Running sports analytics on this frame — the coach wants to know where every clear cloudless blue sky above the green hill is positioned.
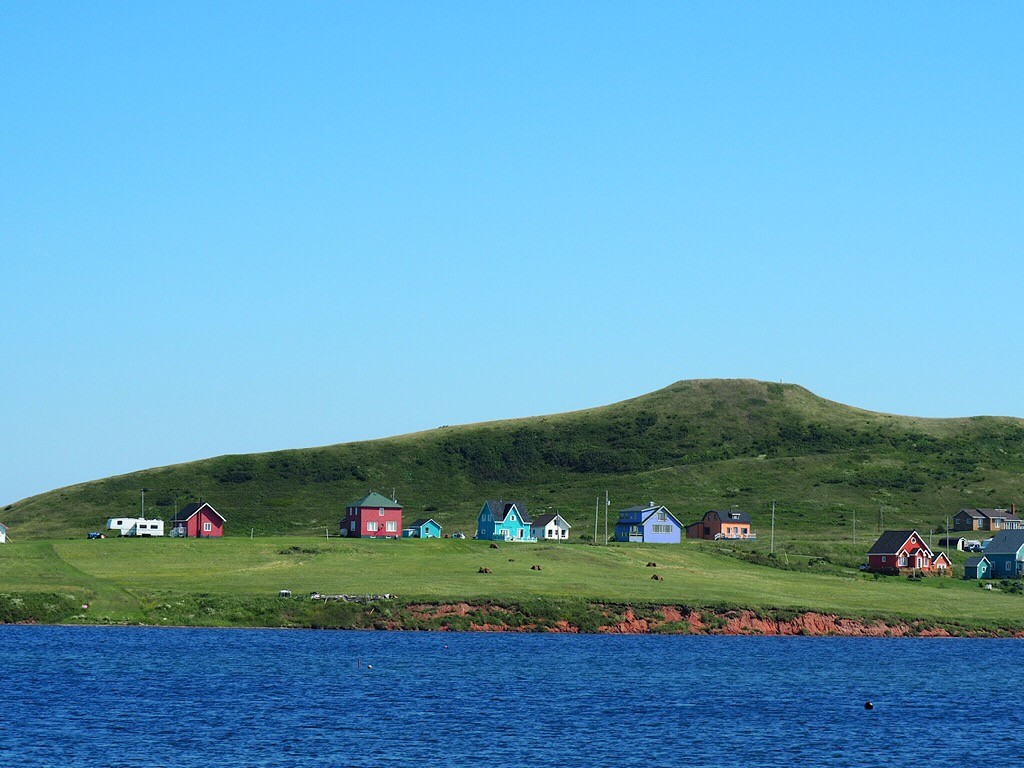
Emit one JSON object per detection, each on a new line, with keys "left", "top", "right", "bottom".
{"left": 0, "top": 2, "right": 1024, "bottom": 502}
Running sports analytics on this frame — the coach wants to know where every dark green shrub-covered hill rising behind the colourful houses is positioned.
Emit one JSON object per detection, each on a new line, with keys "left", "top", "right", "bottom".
{"left": 6, "top": 380, "right": 1024, "bottom": 542}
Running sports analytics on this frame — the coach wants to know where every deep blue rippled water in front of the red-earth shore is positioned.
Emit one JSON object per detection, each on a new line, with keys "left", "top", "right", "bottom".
{"left": 0, "top": 626, "right": 1024, "bottom": 768}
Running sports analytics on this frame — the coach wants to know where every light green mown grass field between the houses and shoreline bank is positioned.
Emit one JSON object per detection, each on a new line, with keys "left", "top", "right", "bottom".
{"left": 0, "top": 537, "right": 1024, "bottom": 629}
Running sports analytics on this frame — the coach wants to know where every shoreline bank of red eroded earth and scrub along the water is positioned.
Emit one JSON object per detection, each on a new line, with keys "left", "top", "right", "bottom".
{"left": 8, "top": 595, "right": 1024, "bottom": 639}
